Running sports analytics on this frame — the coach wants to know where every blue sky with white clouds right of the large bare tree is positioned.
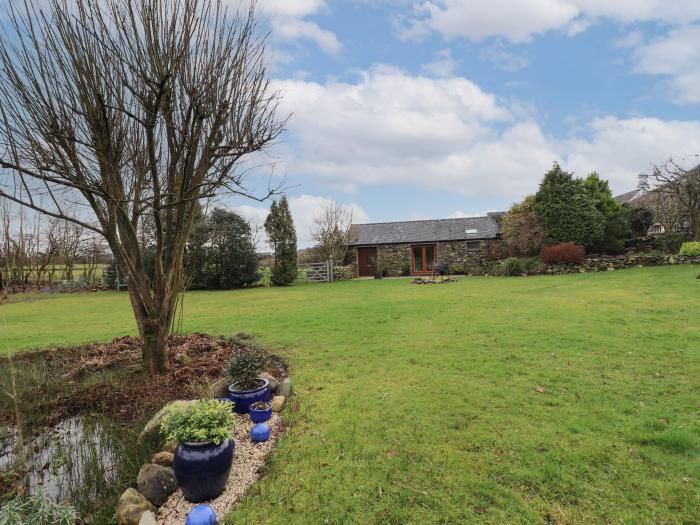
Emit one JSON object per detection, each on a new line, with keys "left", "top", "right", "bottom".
{"left": 221, "top": 0, "right": 700, "bottom": 245}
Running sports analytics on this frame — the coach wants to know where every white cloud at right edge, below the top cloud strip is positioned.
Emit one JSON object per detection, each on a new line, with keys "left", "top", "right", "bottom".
{"left": 633, "top": 24, "right": 700, "bottom": 104}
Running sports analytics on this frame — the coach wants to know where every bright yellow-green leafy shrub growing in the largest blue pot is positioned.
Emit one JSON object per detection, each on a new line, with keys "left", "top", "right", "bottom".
{"left": 160, "top": 399, "right": 233, "bottom": 445}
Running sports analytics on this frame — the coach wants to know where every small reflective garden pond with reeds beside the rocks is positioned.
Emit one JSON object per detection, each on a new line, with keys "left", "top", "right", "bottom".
{"left": 0, "top": 417, "right": 149, "bottom": 524}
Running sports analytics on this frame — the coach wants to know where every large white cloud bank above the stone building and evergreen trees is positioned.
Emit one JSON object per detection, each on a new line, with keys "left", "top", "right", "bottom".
{"left": 276, "top": 66, "right": 700, "bottom": 202}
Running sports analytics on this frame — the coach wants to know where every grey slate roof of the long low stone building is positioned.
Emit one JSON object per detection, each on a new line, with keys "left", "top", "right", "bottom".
{"left": 348, "top": 214, "right": 500, "bottom": 246}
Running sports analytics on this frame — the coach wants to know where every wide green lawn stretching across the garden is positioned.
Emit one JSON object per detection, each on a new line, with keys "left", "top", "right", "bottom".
{"left": 0, "top": 267, "right": 700, "bottom": 525}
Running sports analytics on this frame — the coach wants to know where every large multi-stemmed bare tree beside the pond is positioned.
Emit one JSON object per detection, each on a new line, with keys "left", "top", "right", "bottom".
{"left": 0, "top": 0, "right": 285, "bottom": 373}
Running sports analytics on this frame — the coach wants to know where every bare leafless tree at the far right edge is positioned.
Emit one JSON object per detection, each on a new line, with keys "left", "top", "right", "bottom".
{"left": 639, "top": 159, "right": 700, "bottom": 241}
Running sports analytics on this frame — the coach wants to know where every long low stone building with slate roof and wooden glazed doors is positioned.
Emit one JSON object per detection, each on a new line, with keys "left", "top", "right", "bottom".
{"left": 345, "top": 213, "right": 502, "bottom": 277}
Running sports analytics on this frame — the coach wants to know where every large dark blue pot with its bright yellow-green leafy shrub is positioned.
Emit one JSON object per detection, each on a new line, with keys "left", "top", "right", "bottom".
{"left": 161, "top": 399, "right": 235, "bottom": 503}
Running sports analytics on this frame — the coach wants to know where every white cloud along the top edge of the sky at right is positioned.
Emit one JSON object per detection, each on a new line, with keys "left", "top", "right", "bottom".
{"left": 400, "top": 0, "right": 700, "bottom": 42}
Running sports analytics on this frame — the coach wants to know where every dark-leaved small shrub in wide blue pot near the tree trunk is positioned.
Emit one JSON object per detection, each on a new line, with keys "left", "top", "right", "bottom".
{"left": 227, "top": 346, "right": 270, "bottom": 414}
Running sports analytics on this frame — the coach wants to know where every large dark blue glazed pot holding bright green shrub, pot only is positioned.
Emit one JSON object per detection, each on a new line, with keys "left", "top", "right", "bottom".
{"left": 173, "top": 439, "right": 236, "bottom": 503}
